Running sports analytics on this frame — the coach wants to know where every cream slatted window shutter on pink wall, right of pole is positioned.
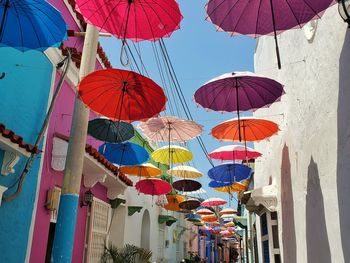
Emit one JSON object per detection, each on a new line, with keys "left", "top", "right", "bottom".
{"left": 85, "top": 197, "right": 111, "bottom": 263}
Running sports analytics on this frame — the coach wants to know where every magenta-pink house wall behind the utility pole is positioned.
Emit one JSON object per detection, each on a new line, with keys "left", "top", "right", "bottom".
{"left": 30, "top": 0, "right": 112, "bottom": 263}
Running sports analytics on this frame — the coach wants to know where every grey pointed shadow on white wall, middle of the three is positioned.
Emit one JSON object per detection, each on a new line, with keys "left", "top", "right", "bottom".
{"left": 306, "top": 157, "right": 332, "bottom": 263}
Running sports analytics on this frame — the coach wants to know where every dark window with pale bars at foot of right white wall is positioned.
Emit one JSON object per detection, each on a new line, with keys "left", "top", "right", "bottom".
{"left": 260, "top": 211, "right": 281, "bottom": 263}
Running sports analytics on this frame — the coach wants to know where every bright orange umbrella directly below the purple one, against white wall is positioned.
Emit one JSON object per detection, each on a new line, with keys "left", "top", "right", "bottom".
{"left": 211, "top": 117, "right": 278, "bottom": 142}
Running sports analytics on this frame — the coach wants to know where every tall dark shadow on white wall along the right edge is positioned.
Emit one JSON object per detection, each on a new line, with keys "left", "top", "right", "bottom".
{"left": 337, "top": 29, "right": 350, "bottom": 262}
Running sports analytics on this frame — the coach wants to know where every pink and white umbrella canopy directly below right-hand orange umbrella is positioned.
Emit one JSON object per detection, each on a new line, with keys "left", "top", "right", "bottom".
{"left": 208, "top": 145, "right": 261, "bottom": 161}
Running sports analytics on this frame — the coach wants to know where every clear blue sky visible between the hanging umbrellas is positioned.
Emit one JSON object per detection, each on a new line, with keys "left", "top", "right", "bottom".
{"left": 100, "top": 0, "right": 255, "bottom": 206}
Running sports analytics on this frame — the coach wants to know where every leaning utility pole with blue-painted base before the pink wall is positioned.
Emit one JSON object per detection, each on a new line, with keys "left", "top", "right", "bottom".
{"left": 51, "top": 24, "right": 98, "bottom": 263}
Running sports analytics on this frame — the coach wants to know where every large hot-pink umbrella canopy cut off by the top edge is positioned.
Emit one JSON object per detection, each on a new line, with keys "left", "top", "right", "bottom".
{"left": 75, "top": 0, "right": 182, "bottom": 41}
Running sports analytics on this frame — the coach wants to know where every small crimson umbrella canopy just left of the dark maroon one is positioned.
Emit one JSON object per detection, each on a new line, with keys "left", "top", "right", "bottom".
{"left": 135, "top": 178, "right": 172, "bottom": 196}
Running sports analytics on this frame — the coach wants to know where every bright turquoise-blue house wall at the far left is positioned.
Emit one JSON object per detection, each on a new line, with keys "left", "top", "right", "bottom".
{"left": 0, "top": 48, "right": 53, "bottom": 262}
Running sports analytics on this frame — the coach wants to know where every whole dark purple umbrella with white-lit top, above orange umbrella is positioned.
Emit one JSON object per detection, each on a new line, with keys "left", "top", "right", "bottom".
{"left": 194, "top": 72, "right": 284, "bottom": 138}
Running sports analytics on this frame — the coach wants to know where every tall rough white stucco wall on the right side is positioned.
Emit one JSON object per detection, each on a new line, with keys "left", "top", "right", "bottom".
{"left": 254, "top": 6, "right": 350, "bottom": 263}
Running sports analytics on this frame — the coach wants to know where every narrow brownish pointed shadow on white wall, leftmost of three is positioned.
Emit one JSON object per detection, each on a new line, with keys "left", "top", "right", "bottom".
{"left": 281, "top": 145, "right": 297, "bottom": 263}
